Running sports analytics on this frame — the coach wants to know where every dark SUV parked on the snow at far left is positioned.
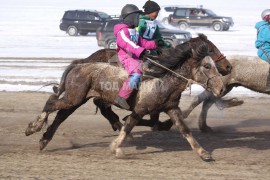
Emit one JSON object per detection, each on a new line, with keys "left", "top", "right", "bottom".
{"left": 60, "top": 10, "right": 112, "bottom": 36}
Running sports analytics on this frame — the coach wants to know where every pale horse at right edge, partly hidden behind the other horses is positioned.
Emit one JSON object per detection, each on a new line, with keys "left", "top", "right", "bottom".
{"left": 180, "top": 56, "right": 270, "bottom": 132}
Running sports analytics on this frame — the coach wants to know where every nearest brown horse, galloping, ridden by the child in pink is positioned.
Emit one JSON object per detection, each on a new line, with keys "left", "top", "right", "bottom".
{"left": 25, "top": 43, "right": 223, "bottom": 161}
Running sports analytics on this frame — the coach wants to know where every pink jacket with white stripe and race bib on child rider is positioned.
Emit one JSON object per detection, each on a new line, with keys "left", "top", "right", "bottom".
{"left": 114, "top": 24, "right": 157, "bottom": 62}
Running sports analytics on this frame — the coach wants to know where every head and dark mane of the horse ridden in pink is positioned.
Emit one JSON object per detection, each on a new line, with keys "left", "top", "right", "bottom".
{"left": 146, "top": 41, "right": 224, "bottom": 96}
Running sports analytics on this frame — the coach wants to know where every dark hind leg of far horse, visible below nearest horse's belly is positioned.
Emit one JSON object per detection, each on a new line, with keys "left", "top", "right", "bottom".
{"left": 93, "top": 98, "right": 123, "bottom": 131}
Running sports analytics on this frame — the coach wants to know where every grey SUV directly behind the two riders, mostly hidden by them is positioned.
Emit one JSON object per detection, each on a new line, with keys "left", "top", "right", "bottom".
{"left": 96, "top": 19, "right": 191, "bottom": 49}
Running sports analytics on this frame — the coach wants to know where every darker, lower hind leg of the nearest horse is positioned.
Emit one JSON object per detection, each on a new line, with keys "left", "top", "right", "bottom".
{"left": 39, "top": 100, "right": 87, "bottom": 150}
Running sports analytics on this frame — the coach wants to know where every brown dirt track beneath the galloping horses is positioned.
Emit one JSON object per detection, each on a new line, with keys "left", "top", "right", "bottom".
{"left": 0, "top": 92, "right": 270, "bottom": 180}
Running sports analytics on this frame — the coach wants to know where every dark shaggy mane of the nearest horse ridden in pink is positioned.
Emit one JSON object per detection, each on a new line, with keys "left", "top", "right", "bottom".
{"left": 144, "top": 41, "right": 209, "bottom": 77}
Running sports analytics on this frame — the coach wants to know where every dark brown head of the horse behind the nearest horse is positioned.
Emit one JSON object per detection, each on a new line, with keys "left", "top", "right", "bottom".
{"left": 189, "top": 34, "right": 232, "bottom": 76}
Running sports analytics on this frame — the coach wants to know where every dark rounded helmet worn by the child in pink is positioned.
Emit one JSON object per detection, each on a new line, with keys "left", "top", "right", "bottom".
{"left": 121, "top": 4, "right": 142, "bottom": 26}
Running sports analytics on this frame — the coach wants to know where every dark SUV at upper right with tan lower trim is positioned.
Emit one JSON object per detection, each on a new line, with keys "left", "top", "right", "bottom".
{"left": 169, "top": 7, "right": 234, "bottom": 31}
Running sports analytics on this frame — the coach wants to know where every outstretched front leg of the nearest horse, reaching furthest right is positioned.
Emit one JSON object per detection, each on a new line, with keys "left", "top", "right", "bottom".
{"left": 166, "top": 107, "right": 213, "bottom": 161}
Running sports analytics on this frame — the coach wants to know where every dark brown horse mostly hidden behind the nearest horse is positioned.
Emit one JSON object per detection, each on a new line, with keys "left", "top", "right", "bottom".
{"left": 54, "top": 34, "right": 231, "bottom": 131}
